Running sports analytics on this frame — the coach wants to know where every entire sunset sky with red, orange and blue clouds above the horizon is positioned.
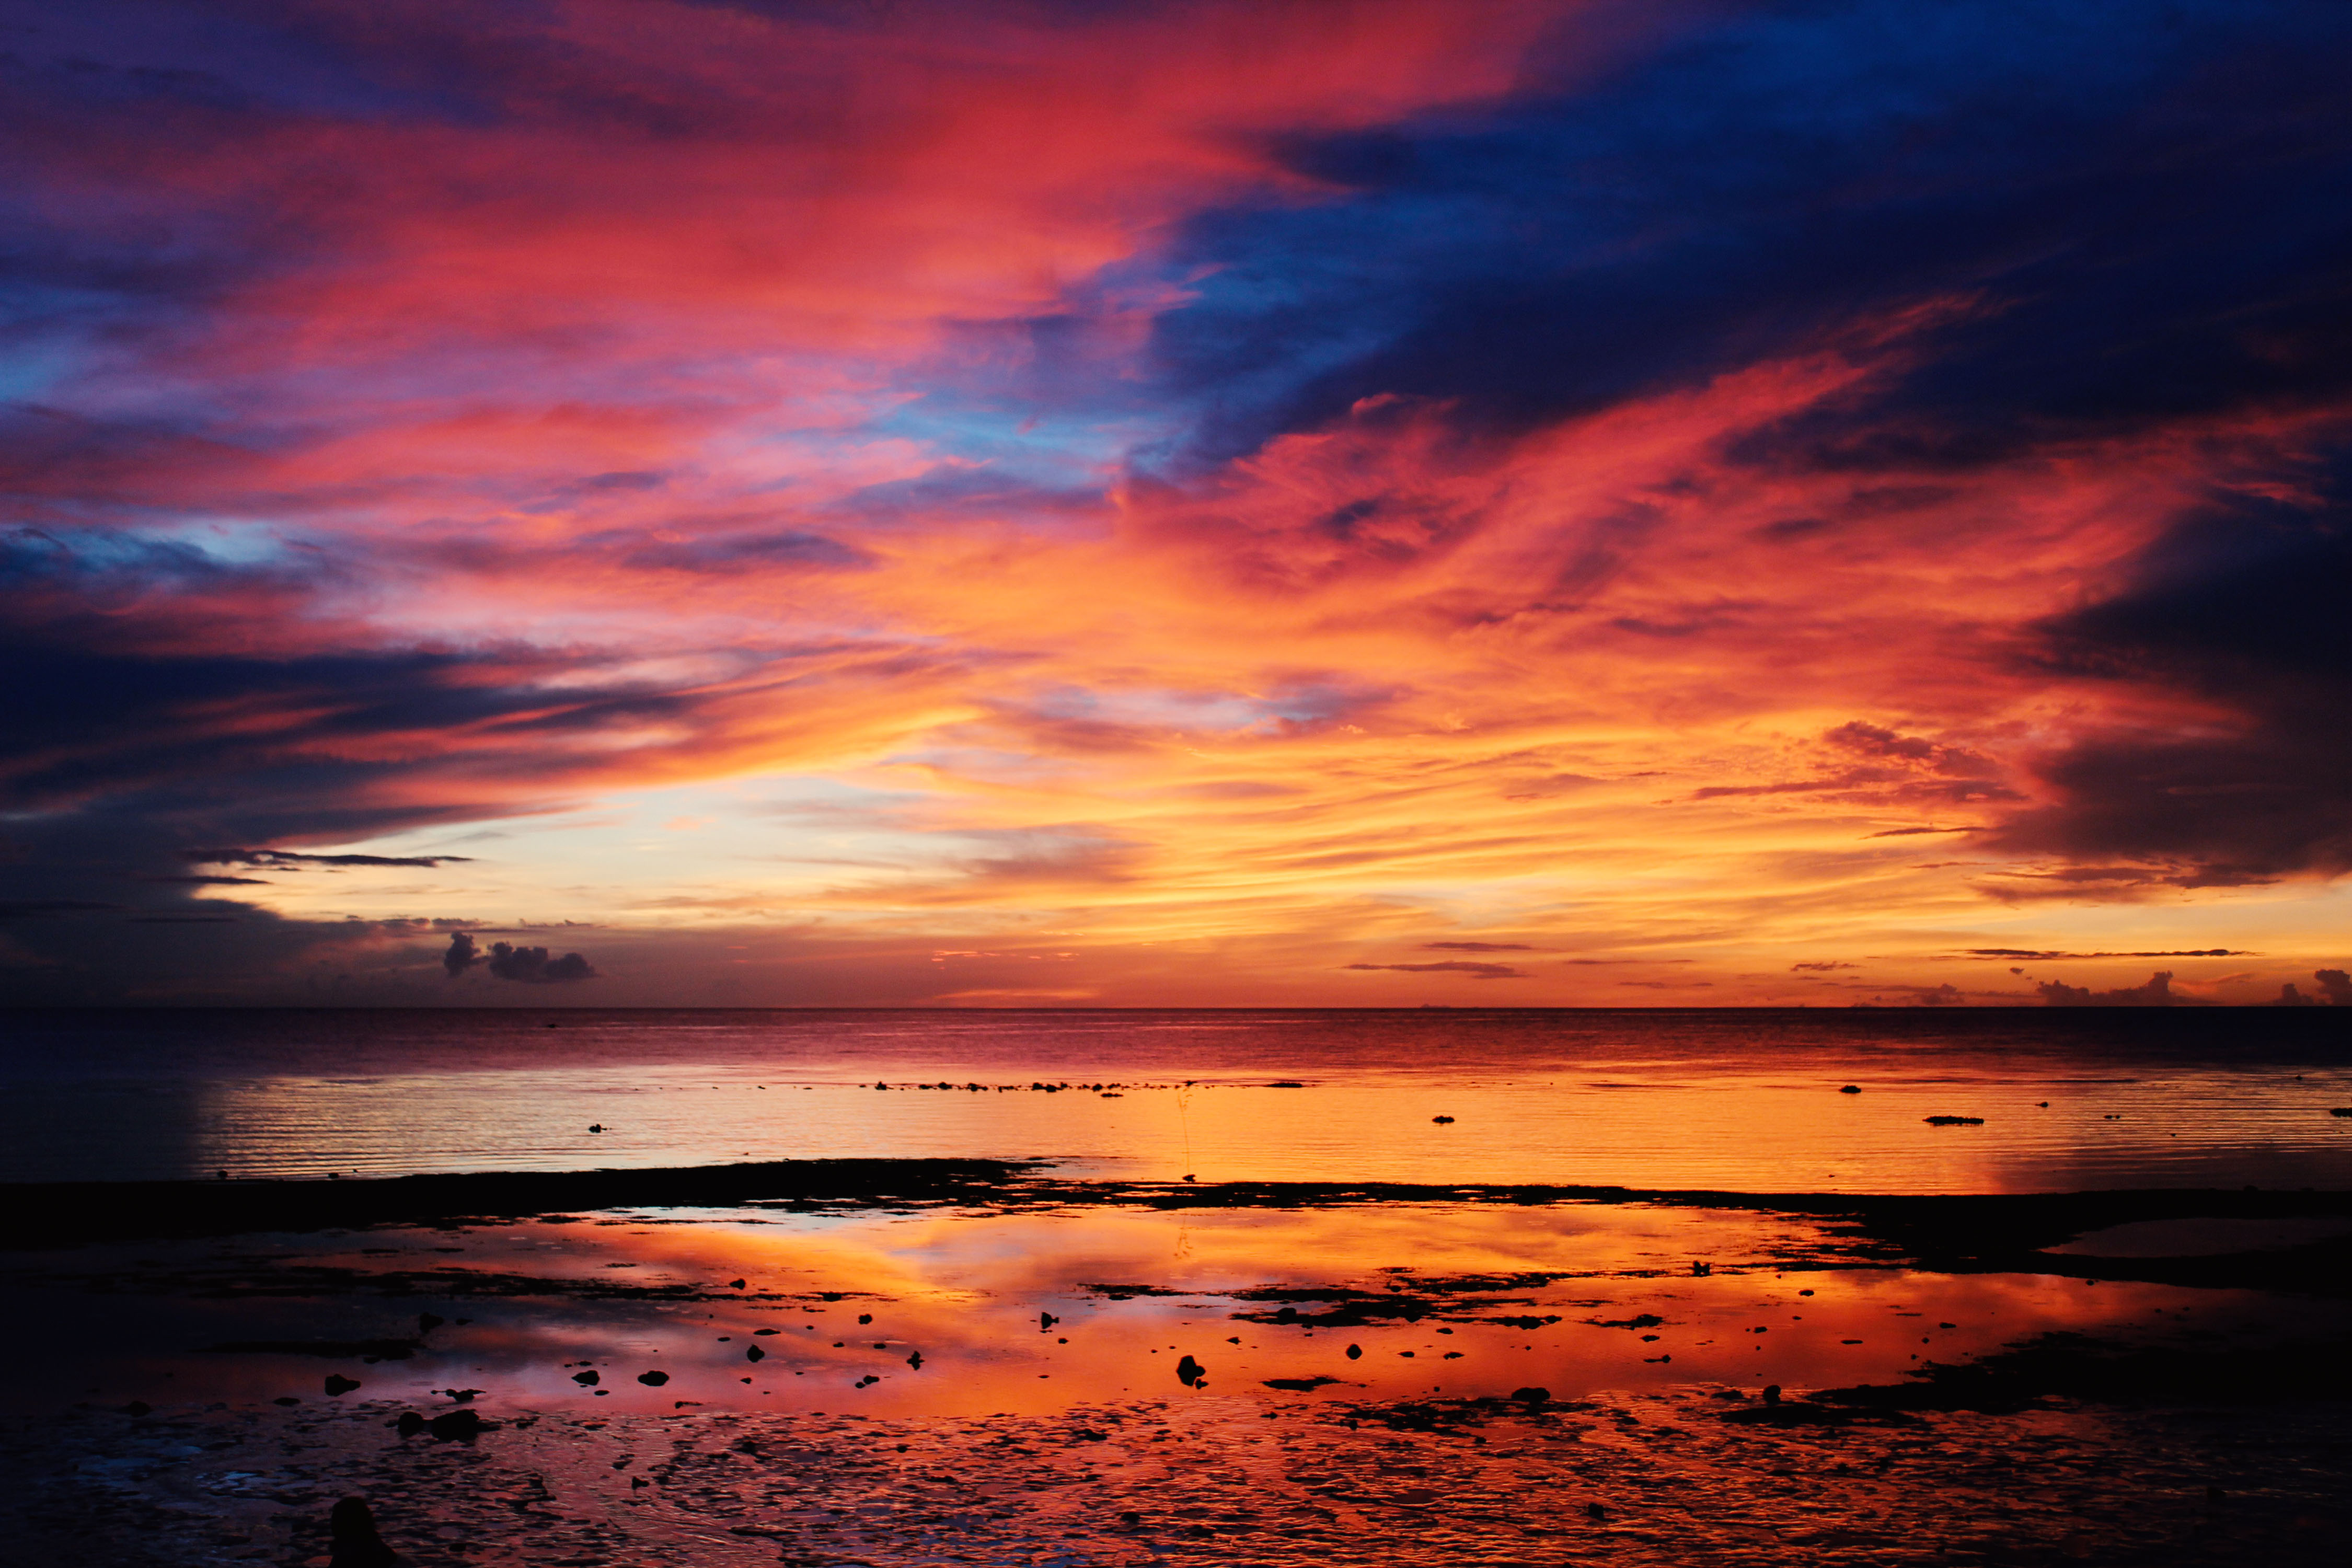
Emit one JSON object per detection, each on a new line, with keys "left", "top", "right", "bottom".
{"left": 0, "top": 0, "right": 2352, "bottom": 1006}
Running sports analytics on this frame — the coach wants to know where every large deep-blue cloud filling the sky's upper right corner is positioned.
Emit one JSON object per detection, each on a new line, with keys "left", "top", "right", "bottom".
{"left": 1138, "top": 0, "right": 2352, "bottom": 466}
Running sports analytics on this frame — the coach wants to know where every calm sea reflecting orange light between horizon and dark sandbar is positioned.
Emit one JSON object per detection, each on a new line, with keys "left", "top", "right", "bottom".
{"left": 0, "top": 1009, "right": 2352, "bottom": 1192}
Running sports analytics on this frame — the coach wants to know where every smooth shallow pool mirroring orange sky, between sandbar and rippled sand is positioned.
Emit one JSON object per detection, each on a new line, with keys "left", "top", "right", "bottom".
{"left": 12, "top": 1204, "right": 2331, "bottom": 1417}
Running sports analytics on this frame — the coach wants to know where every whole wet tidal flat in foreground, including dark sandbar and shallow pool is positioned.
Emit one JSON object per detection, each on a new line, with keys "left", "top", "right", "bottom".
{"left": 0, "top": 1161, "right": 2352, "bottom": 1568}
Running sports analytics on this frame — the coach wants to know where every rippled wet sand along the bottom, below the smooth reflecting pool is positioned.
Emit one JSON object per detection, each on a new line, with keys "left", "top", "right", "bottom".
{"left": 0, "top": 1389, "right": 2352, "bottom": 1568}
